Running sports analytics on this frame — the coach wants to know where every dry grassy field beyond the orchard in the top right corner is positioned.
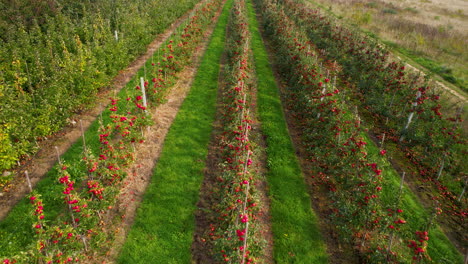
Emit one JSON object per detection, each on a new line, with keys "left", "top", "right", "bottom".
{"left": 308, "top": 0, "right": 468, "bottom": 96}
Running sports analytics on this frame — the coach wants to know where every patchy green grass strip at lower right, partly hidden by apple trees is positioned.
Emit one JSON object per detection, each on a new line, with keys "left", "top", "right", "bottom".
{"left": 361, "top": 133, "right": 463, "bottom": 264}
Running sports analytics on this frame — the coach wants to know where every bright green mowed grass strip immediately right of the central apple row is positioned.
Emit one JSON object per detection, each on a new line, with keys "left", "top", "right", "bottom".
{"left": 247, "top": 0, "right": 328, "bottom": 263}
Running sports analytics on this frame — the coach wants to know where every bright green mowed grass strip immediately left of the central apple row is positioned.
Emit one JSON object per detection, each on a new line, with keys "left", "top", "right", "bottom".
{"left": 118, "top": 0, "right": 233, "bottom": 263}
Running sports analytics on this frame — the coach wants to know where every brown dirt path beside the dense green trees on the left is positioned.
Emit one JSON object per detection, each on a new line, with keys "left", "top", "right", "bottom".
{"left": 0, "top": 3, "right": 200, "bottom": 221}
